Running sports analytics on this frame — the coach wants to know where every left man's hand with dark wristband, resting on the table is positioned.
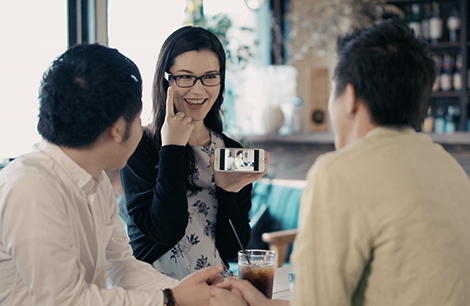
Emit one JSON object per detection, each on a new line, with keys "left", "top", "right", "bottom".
{"left": 172, "top": 265, "right": 223, "bottom": 306}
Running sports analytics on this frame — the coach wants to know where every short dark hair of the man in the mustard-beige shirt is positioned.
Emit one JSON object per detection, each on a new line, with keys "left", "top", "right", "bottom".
{"left": 334, "top": 19, "right": 435, "bottom": 129}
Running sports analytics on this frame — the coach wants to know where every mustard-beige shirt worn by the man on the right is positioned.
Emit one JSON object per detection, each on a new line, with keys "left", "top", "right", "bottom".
{"left": 291, "top": 127, "right": 470, "bottom": 306}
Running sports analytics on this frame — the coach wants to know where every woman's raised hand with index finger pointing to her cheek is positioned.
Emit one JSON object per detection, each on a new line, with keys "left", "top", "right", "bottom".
{"left": 161, "top": 86, "right": 194, "bottom": 146}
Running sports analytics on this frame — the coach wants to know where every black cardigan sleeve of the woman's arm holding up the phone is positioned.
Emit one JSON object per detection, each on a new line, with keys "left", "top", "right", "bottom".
{"left": 215, "top": 135, "right": 252, "bottom": 260}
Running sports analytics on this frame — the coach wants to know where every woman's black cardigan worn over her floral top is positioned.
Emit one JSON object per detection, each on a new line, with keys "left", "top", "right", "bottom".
{"left": 121, "top": 131, "right": 252, "bottom": 264}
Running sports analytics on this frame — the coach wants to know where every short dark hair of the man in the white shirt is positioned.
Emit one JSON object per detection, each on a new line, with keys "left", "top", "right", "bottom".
{"left": 38, "top": 44, "right": 142, "bottom": 148}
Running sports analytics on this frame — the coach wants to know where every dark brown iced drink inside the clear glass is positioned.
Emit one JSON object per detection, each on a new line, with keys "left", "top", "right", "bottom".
{"left": 238, "top": 262, "right": 274, "bottom": 299}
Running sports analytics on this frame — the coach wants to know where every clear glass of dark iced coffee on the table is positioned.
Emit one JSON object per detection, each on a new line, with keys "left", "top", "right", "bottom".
{"left": 238, "top": 250, "right": 276, "bottom": 299}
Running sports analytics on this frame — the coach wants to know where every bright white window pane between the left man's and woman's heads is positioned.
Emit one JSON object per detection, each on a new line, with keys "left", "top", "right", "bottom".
{"left": 108, "top": 0, "right": 186, "bottom": 125}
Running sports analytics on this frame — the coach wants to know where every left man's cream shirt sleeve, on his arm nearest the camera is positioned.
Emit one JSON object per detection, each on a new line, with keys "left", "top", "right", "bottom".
{"left": 0, "top": 176, "right": 163, "bottom": 306}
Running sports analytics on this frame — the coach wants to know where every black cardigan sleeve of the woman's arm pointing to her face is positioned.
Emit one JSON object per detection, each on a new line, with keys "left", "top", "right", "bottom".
{"left": 121, "top": 133, "right": 188, "bottom": 262}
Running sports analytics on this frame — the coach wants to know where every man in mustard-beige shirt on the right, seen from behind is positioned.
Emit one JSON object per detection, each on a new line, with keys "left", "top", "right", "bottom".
{"left": 211, "top": 20, "right": 470, "bottom": 306}
